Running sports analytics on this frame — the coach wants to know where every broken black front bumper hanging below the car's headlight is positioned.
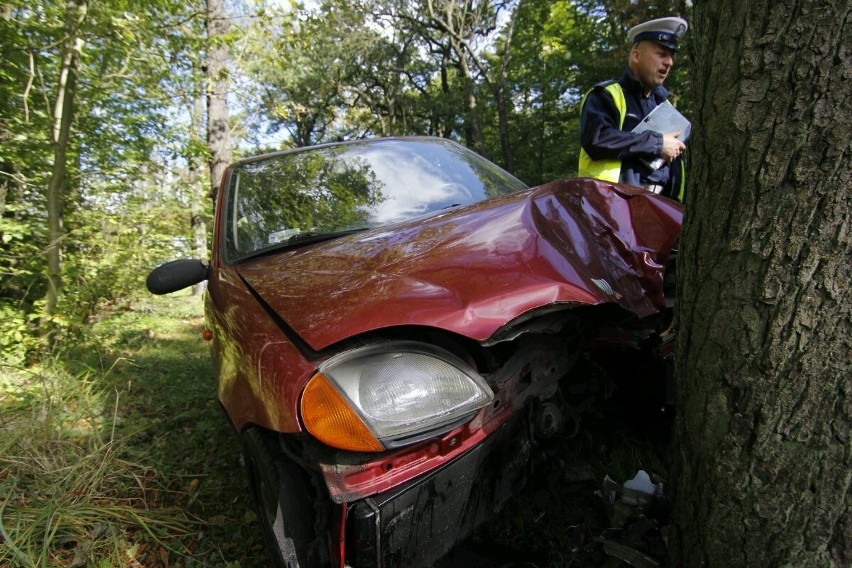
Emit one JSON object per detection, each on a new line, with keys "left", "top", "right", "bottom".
{"left": 345, "top": 415, "right": 532, "bottom": 568}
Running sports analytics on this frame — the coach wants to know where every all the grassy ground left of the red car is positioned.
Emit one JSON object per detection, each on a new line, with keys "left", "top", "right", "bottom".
{"left": 0, "top": 295, "right": 264, "bottom": 568}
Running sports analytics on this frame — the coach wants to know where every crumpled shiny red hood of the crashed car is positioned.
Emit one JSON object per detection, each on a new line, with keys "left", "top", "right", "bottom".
{"left": 238, "top": 179, "right": 682, "bottom": 350}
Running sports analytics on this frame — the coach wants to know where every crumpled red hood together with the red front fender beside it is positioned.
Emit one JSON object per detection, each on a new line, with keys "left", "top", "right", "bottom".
{"left": 207, "top": 179, "right": 682, "bottom": 432}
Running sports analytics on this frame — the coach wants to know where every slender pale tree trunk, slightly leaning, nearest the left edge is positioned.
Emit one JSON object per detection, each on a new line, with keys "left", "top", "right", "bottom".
{"left": 45, "top": 0, "right": 87, "bottom": 320}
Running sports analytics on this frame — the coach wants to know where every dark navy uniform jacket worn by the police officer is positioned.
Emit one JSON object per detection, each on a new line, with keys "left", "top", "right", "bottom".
{"left": 580, "top": 68, "right": 683, "bottom": 199}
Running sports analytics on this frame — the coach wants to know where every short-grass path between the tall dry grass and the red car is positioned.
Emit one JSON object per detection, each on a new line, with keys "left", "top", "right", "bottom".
{"left": 69, "top": 297, "right": 267, "bottom": 568}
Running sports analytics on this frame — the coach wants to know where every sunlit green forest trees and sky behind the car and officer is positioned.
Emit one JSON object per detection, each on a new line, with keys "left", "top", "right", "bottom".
{"left": 0, "top": 0, "right": 689, "bottom": 356}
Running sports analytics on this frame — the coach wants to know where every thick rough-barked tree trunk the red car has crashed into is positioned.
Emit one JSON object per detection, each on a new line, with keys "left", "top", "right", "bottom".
{"left": 670, "top": 0, "right": 852, "bottom": 568}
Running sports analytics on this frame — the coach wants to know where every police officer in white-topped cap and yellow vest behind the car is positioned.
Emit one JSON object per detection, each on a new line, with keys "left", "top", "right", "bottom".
{"left": 579, "top": 17, "right": 687, "bottom": 201}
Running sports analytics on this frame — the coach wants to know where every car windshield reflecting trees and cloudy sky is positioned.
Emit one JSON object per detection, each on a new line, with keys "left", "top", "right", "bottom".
{"left": 224, "top": 138, "right": 526, "bottom": 262}
